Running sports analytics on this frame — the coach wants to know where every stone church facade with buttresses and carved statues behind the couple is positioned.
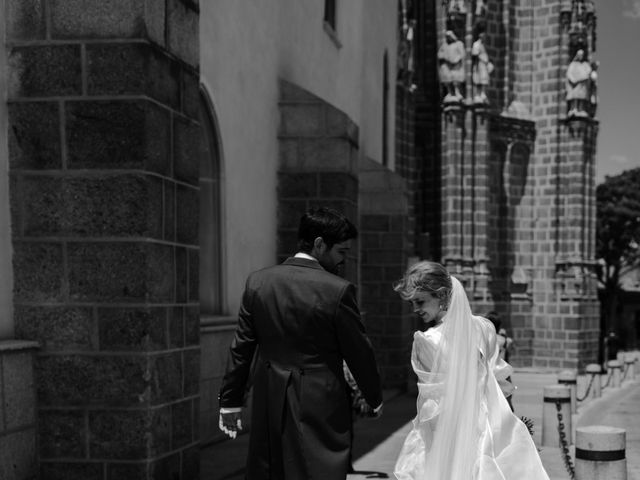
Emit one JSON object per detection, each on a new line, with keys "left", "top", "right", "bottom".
{"left": 0, "top": 0, "right": 599, "bottom": 480}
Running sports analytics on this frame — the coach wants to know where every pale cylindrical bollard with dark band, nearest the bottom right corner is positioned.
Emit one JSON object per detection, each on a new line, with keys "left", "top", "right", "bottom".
{"left": 575, "top": 425, "right": 627, "bottom": 480}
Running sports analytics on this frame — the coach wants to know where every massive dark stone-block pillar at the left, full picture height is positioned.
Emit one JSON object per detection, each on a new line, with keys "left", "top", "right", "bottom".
{"left": 7, "top": 0, "right": 200, "bottom": 480}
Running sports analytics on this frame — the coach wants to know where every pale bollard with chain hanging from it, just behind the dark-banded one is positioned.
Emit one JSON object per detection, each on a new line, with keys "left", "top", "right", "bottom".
{"left": 542, "top": 385, "right": 571, "bottom": 447}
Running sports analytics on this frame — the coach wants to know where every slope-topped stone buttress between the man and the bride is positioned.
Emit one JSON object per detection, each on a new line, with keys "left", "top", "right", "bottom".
{"left": 358, "top": 159, "right": 410, "bottom": 389}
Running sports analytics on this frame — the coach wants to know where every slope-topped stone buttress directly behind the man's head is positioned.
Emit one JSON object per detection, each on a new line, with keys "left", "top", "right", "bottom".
{"left": 278, "top": 80, "right": 358, "bottom": 283}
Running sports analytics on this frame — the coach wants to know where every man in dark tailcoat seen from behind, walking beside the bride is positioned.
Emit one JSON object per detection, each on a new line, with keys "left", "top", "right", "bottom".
{"left": 219, "top": 208, "right": 382, "bottom": 480}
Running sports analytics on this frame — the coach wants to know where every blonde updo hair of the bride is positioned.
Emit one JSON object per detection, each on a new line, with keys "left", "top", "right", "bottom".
{"left": 393, "top": 260, "right": 452, "bottom": 309}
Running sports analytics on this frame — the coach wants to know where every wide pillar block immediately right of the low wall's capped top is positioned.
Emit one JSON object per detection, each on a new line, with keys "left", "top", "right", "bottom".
{"left": 36, "top": 355, "right": 151, "bottom": 407}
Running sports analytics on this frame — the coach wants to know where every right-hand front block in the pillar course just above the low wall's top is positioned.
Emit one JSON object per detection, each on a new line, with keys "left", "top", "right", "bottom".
{"left": 97, "top": 308, "right": 168, "bottom": 352}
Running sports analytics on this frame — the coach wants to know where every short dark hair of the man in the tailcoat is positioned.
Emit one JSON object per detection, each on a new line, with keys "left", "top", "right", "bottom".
{"left": 298, "top": 207, "right": 358, "bottom": 253}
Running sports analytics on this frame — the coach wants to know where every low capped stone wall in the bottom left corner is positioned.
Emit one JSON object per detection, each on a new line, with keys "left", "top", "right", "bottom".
{"left": 0, "top": 340, "right": 38, "bottom": 480}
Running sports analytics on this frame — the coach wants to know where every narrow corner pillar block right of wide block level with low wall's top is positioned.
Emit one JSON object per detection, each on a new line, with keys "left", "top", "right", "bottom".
{"left": 149, "top": 352, "right": 181, "bottom": 403}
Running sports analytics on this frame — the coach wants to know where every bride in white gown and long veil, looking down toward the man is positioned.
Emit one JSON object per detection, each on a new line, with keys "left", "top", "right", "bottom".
{"left": 394, "top": 261, "right": 549, "bottom": 480}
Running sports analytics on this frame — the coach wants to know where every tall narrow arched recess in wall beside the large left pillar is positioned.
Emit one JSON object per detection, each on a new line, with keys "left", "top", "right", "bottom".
{"left": 199, "top": 86, "right": 225, "bottom": 318}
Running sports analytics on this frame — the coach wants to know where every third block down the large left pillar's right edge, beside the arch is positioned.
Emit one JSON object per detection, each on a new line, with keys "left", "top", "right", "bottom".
{"left": 173, "top": 117, "right": 203, "bottom": 186}
